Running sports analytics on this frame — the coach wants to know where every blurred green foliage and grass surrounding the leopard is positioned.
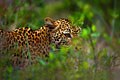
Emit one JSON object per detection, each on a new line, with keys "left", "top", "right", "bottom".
{"left": 0, "top": 0, "right": 120, "bottom": 80}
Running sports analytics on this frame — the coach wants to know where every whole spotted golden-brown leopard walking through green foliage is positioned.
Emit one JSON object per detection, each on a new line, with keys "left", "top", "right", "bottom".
{"left": 0, "top": 17, "right": 81, "bottom": 69}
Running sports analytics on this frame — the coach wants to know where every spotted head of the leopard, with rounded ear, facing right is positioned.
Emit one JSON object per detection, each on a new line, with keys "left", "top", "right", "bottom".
{"left": 45, "top": 17, "right": 81, "bottom": 46}
